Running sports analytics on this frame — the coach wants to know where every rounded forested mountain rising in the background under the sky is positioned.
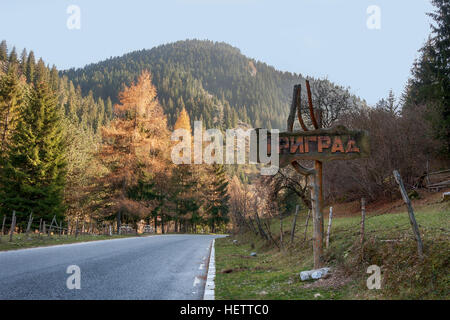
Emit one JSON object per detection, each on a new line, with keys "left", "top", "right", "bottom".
{"left": 62, "top": 40, "right": 362, "bottom": 129}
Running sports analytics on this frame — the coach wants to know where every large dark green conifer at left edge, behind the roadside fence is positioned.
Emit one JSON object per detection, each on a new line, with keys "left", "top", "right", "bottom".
{"left": 0, "top": 82, "right": 66, "bottom": 220}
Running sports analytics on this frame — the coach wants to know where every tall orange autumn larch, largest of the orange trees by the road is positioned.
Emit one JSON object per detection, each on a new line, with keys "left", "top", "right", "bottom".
{"left": 98, "top": 72, "right": 169, "bottom": 228}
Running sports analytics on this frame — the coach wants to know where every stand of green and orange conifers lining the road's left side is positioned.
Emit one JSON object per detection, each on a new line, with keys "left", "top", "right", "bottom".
{"left": 0, "top": 41, "right": 232, "bottom": 233}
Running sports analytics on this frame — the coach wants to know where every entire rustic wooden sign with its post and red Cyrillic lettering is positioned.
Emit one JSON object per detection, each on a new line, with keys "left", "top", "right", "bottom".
{"left": 258, "top": 80, "right": 370, "bottom": 269}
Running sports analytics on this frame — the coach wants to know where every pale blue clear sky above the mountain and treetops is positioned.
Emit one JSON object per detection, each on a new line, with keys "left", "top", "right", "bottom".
{"left": 0, "top": 0, "right": 433, "bottom": 104}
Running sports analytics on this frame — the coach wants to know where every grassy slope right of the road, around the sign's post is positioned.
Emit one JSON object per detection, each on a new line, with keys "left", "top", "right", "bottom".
{"left": 216, "top": 203, "right": 450, "bottom": 300}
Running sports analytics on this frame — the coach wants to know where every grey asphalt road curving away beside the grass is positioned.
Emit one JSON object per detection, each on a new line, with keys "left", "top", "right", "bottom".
{"left": 0, "top": 235, "right": 222, "bottom": 300}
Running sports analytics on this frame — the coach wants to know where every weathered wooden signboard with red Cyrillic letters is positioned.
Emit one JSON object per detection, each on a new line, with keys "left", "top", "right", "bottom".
{"left": 258, "top": 126, "right": 370, "bottom": 167}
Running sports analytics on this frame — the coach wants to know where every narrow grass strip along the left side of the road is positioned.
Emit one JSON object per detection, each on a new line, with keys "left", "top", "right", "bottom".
{"left": 0, "top": 234, "right": 149, "bottom": 251}
